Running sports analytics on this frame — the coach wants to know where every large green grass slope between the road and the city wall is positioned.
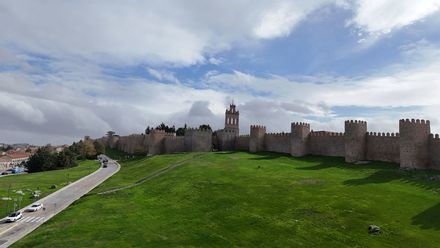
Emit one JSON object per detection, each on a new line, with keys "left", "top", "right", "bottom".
{"left": 15, "top": 152, "right": 440, "bottom": 247}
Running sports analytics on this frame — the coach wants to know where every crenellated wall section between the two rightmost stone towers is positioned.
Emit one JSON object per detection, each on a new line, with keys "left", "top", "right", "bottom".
{"left": 366, "top": 132, "right": 400, "bottom": 163}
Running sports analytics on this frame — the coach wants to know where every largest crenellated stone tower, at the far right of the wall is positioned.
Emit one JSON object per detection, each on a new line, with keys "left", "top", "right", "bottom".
{"left": 399, "top": 119, "right": 431, "bottom": 169}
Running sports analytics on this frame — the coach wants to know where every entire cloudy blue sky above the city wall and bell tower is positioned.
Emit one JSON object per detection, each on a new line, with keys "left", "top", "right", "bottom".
{"left": 0, "top": 0, "right": 440, "bottom": 144}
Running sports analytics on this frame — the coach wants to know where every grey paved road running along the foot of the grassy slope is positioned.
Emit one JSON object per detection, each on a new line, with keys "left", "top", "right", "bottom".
{"left": 0, "top": 158, "right": 120, "bottom": 248}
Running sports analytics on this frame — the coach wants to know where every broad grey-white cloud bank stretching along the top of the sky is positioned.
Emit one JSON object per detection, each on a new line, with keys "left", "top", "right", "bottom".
{"left": 0, "top": 0, "right": 439, "bottom": 66}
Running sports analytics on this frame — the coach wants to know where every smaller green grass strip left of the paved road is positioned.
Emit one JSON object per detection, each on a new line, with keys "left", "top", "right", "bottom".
{"left": 0, "top": 161, "right": 99, "bottom": 219}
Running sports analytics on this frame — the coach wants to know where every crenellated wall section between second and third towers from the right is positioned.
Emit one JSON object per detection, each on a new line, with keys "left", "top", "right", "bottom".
{"left": 309, "top": 132, "right": 345, "bottom": 157}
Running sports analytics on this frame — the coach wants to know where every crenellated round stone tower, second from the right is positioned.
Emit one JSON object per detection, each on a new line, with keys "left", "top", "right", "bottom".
{"left": 345, "top": 120, "right": 367, "bottom": 163}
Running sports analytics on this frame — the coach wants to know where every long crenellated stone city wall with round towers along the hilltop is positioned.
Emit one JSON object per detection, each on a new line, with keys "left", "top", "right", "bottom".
{"left": 97, "top": 116, "right": 440, "bottom": 169}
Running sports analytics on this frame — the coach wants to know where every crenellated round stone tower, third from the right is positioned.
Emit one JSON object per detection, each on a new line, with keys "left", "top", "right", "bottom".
{"left": 290, "top": 122, "right": 310, "bottom": 157}
